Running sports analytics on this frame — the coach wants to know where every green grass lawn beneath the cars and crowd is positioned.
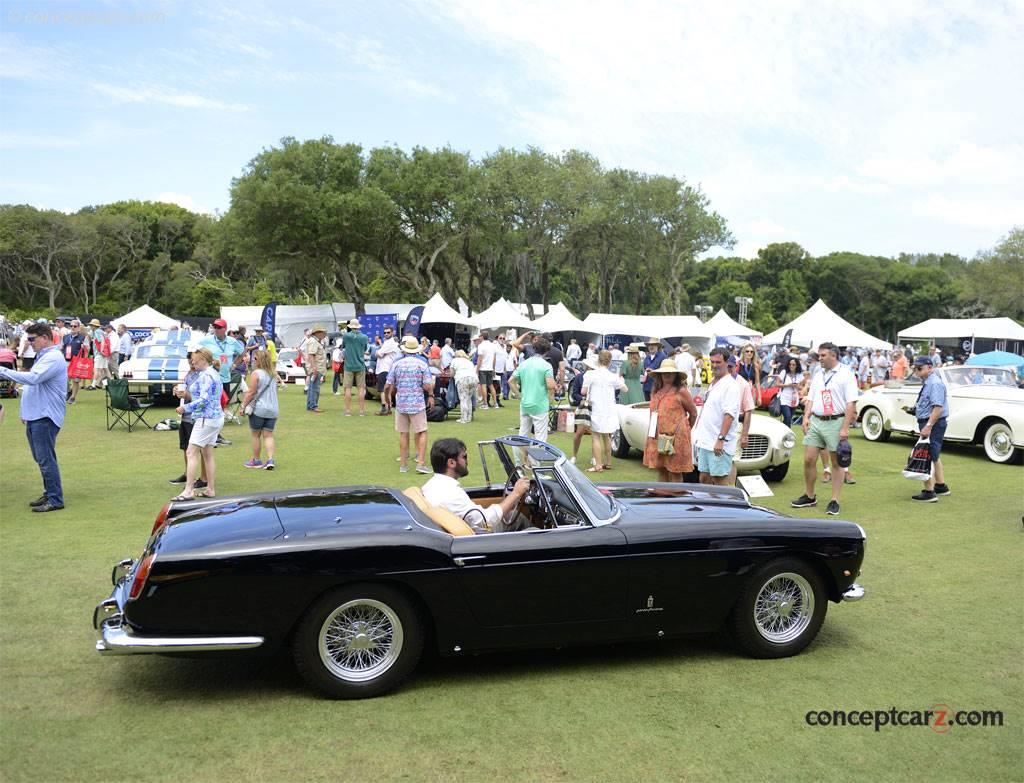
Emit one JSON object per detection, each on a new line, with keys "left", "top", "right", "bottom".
{"left": 0, "top": 387, "right": 1024, "bottom": 781}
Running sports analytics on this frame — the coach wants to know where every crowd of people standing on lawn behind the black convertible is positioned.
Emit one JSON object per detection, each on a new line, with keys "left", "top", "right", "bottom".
{"left": 0, "top": 311, "right": 962, "bottom": 524}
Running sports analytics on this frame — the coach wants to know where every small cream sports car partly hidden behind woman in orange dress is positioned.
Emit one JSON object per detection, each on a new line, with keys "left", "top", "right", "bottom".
{"left": 611, "top": 402, "right": 797, "bottom": 481}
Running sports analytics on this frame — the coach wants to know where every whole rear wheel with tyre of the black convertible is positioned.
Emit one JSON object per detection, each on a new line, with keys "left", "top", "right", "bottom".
{"left": 294, "top": 584, "right": 424, "bottom": 699}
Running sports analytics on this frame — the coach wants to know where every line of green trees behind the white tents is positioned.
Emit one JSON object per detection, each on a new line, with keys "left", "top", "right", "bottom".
{"left": 0, "top": 137, "right": 1024, "bottom": 339}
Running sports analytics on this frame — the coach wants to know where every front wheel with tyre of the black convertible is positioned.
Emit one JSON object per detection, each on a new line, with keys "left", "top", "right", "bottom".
{"left": 729, "top": 558, "right": 827, "bottom": 658}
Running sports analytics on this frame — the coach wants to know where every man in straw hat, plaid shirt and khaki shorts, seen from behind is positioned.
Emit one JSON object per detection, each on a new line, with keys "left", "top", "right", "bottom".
{"left": 384, "top": 335, "right": 434, "bottom": 473}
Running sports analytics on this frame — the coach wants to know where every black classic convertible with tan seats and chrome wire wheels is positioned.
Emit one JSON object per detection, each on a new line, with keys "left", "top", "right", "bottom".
{"left": 93, "top": 435, "right": 864, "bottom": 698}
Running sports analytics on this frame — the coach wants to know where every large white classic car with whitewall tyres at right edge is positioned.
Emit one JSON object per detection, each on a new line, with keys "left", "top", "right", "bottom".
{"left": 857, "top": 365, "right": 1024, "bottom": 463}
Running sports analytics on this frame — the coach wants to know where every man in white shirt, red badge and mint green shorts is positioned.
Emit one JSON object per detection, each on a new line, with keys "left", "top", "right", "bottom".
{"left": 790, "top": 343, "right": 858, "bottom": 516}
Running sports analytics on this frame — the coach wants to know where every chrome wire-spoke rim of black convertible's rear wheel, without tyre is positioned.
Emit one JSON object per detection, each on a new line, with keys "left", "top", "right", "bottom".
{"left": 319, "top": 599, "right": 403, "bottom": 683}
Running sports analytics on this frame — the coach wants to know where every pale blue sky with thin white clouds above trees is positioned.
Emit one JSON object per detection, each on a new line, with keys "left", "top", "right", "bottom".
{"left": 0, "top": 0, "right": 1024, "bottom": 257}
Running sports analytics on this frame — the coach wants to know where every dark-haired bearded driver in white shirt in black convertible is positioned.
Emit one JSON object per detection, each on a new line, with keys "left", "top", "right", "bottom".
{"left": 423, "top": 438, "right": 529, "bottom": 533}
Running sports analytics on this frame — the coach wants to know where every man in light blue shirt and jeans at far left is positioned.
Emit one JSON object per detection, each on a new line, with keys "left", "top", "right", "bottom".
{"left": 0, "top": 323, "right": 68, "bottom": 512}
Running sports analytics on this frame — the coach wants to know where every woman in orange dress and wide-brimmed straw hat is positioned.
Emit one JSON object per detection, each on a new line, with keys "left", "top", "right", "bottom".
{"left": 643, "top": 359, "right": 697, "bottom": 481}
